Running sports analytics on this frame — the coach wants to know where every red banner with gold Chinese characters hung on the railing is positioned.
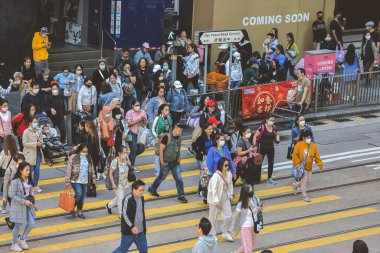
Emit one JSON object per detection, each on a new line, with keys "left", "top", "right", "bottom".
{"left": 242, "top": 80, "right": 297, "bottom": 120}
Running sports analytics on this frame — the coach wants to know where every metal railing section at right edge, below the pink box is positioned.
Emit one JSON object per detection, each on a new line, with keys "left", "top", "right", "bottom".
{"left": 313, "top": 71, "right": 380, "bottom": 112}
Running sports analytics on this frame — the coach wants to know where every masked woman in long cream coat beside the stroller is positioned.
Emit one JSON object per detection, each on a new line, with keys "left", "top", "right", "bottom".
{"left": 22, "top": 117, "right": 43, "bottom": 192}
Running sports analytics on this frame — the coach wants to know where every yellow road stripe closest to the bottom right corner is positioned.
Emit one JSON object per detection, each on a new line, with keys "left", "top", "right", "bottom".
{"left": 262, "top": 227, "right": 380, "bottom": 253}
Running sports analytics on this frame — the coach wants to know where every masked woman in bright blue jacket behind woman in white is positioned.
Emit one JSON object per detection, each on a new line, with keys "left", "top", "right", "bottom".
{"left": 206, "top": 134, "right": 236, "bottom": 178}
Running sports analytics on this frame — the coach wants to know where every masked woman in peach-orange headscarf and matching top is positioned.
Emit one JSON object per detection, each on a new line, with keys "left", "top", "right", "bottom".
{"left": 95, "top": 106, "right": 115, "bottom": 161}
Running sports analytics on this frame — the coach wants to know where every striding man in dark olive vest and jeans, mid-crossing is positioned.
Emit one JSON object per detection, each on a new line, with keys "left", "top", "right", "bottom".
{"left": 148, "top": 123, "right": 187, "bottom": 203}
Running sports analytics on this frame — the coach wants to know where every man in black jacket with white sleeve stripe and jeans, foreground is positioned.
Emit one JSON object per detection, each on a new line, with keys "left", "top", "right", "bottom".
{"left": 113, "top": 180, "right": 148, "bottom": 253}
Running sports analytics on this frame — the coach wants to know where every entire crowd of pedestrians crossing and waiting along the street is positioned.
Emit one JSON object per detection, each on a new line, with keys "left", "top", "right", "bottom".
{"left": 0, "top": 12, "right": 378, "bottom": 252}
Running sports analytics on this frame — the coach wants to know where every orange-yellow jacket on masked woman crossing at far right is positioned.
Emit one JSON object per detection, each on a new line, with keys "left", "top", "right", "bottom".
{"left": 292, "top": 141, "right": 323, "bottom": 171}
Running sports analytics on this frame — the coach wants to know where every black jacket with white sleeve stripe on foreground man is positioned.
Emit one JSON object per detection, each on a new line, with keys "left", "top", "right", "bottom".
{"left": 121, "top": 193, "right": 146, "bottom": 235}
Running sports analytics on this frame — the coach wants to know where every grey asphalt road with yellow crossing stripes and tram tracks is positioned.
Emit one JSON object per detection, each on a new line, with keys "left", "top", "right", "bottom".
{"left": 0, "top": 111, "right": 380, "bottom": 253}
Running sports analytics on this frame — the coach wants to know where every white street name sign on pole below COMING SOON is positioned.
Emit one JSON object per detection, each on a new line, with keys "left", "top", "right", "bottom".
{"left": 200, "top": 30, "right": 244, "bottom": 45}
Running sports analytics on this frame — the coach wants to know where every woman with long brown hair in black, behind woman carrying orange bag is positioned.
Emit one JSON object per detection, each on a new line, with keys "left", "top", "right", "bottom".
{"left": 84, "top": 120, "right": 104, "bottom": 180}
